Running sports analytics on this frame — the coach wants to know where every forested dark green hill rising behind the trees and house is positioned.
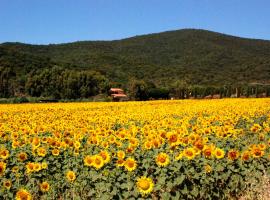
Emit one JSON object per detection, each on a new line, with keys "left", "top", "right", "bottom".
{"left": 0, "top": 29, "right": 270, "bottom": 99}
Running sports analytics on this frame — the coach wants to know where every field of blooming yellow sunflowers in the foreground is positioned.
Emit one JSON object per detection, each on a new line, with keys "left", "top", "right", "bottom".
{"left": 0, "top": 99, "right": 270, "bottom": 200}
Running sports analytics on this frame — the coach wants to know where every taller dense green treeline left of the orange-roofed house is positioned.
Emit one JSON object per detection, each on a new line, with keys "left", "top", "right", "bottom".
{"left": 0, "top": 66, "right": 110, "bottom": 99}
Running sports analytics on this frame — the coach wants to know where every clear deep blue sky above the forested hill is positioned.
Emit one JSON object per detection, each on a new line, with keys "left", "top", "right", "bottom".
{"left": 0, "top": 0, "right": 270, "bottom": 44}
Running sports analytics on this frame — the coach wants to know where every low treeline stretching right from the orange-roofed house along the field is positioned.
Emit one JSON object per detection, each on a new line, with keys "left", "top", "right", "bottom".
{"left": 126, "top": 80, "right": 270, "bottom": 100}
